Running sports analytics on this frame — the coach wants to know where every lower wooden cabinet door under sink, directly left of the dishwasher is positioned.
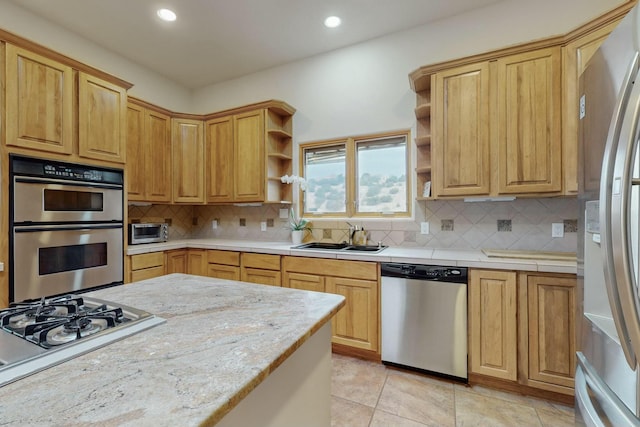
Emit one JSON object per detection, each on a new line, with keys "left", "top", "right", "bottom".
{"left": 326, "top": 277, "right": 378, "bottom": 351}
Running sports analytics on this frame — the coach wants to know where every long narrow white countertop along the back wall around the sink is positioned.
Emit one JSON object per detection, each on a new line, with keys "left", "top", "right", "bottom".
{"left": 127, "top": 239, "right": 576, "bottom": 274}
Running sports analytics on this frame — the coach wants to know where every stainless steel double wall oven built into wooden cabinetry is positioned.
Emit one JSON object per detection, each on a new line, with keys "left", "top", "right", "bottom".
{"left": 9, "top": 155, "right": 124, "bottom": 301}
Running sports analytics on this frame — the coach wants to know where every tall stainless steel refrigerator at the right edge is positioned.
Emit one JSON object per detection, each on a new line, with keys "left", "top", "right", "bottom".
{"left": 575, "top": 6, "right": 640, "bottom": 426}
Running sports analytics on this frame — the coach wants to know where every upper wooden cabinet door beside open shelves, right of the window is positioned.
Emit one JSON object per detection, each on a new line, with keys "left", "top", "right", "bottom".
{"left": 431, "top": 62, "right": 491, "bottom": 197}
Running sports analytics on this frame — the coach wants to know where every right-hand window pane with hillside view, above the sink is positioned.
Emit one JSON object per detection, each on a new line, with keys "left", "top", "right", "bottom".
{"left": 356, "top": 136, "right": 408, "bottom": 213}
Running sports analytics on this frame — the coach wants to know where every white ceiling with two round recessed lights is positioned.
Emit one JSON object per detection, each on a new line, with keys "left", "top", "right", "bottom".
{"left": 10, "top": 0, "right": 500, "bottom": 88}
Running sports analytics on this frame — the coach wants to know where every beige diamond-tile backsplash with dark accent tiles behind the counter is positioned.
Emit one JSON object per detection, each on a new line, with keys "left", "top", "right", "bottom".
{"left": 129, "top": 198, "right": 579, "bottom": 252}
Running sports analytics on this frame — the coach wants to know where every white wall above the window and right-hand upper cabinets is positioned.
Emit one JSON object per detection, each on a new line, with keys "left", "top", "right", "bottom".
{"left": 193, "top": 0, "right": 626, "bottom": 142}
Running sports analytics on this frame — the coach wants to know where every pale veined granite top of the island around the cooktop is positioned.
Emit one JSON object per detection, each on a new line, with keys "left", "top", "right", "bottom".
{"left": 0, "top": 274, "right": 344, "bottom": 427}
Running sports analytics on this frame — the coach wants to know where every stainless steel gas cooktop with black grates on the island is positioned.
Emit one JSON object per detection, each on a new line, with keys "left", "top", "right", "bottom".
{"left": 0, "top": 294, "right": 165, "bottom": 387}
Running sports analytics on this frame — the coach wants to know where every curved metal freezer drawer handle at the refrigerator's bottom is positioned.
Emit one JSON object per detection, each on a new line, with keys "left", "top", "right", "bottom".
{"left": 575, "top": 352, "right": 640, "bottom": 427}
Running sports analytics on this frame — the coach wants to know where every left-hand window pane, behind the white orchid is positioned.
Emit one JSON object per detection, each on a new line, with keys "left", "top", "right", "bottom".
{"left": 304, "top": 144, "right": 347, "bottom": 213}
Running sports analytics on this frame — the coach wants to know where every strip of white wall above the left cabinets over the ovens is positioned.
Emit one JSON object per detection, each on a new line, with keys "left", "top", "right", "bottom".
{"left": 0, "top": 0, "right": 192, "bottom": 112}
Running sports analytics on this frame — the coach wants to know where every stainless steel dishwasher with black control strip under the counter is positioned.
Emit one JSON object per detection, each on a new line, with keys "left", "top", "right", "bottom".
{"left": 381, "top": 263, "right": 467, "bottom": 381}
